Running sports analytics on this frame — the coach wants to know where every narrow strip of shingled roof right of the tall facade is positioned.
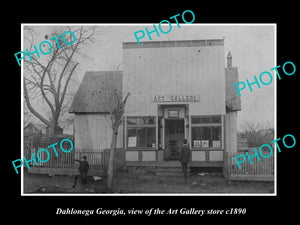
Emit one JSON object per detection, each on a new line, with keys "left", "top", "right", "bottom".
{"left": 225, "top": 67, "right": 242, "bottom": 111}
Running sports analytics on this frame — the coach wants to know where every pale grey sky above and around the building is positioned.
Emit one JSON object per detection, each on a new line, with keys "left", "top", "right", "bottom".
{"left": 24, "top": 23, "right": 277, "bottom": 130}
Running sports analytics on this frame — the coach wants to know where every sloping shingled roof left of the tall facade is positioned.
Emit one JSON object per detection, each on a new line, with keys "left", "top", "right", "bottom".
{"left": 69, "top": 71, "right": 122, "bottom": 113}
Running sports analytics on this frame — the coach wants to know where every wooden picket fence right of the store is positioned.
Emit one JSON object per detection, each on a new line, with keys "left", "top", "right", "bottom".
{"left": 224, "top": 151, "right": 274, "bottom": 181}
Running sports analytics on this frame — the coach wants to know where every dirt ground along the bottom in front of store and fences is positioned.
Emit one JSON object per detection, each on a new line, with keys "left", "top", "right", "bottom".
{"left": 24, "top": 171, "right": 274, "bottom": 194}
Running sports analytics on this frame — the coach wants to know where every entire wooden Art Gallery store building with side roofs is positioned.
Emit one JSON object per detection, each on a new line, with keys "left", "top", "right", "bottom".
{"left": 70, "top": 39, "right": 241, "bottom": 166}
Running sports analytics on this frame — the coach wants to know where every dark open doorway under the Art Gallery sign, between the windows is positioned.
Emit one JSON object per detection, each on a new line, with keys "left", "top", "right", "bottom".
{"left": 164, "top": 118, "right": 185, "bottom": 160}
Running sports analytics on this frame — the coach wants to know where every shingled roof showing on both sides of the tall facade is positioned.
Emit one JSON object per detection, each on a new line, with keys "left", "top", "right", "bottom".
{"left": 69, "top": 67, "right": 241, "bottom": 113}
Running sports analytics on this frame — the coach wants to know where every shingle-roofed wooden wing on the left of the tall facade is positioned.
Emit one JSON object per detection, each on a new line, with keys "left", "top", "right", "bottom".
{"left": 69, "top": 71, "right": 123, "bottom": 149}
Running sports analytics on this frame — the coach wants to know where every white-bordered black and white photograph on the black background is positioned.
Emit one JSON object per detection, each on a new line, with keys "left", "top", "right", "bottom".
{"left": 19, "top": 23, "right": 276, "bottom": 196}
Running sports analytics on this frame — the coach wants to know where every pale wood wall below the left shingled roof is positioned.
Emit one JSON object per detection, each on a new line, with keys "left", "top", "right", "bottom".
{"left": 75, "top": 114, "right": 123, "bottom": 149}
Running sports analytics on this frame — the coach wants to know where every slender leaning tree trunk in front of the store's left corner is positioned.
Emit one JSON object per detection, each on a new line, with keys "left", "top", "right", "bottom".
{"left": 106, "top": 127, "right": 118, "bottom": 192}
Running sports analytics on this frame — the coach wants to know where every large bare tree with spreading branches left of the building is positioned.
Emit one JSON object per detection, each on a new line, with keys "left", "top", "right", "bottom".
{"left": 23, "top": 26, "right": 95, "bottom": 136}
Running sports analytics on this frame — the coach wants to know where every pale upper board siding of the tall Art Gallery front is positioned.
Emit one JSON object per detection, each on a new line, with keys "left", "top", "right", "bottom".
{"left": 123, "top": 45, "right": 225, "bottom": 116}
